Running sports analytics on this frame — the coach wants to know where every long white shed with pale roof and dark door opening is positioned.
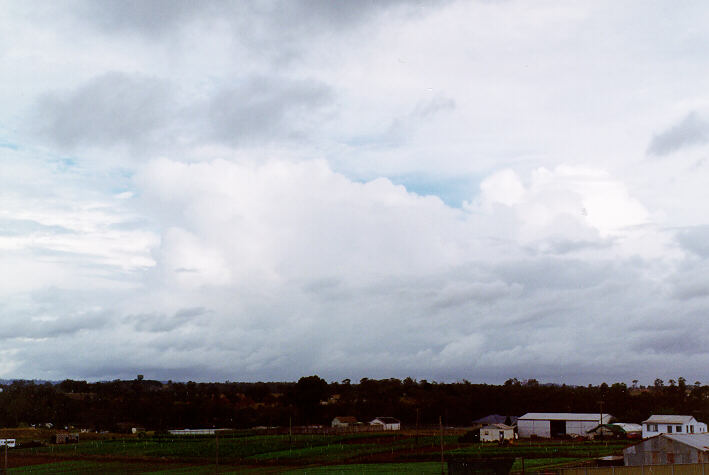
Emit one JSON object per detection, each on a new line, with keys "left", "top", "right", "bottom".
{"left": 517, "top": 412, "right": 613, "bottom": 438}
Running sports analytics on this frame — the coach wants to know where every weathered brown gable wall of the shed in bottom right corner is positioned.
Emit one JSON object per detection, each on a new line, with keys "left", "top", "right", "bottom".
{"left": 623, "top": 437, "right": 709, "bottom": 466}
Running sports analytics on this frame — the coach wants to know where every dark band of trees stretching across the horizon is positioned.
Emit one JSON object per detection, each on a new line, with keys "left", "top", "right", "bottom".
{"left": 0, "top": 376, "right": 709, "bottom": 431}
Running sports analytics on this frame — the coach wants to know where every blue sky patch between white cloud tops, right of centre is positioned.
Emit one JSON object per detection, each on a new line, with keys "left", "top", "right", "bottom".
{"left": 388, "top": 175, "right": 480, "bottom": 208}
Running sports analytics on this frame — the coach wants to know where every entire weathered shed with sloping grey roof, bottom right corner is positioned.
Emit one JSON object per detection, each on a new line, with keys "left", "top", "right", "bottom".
{"left": 623, "top": 433, "right": 709, "bottom": 466}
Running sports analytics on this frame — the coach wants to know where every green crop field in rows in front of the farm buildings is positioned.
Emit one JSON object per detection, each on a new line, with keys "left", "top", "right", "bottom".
{"left": 2, "top": 432, "right": 627, "bottom": 474}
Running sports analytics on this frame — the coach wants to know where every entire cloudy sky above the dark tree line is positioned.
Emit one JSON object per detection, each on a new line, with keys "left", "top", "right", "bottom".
{"left": 0, "top": 0, "right": 709, "bottom": 384}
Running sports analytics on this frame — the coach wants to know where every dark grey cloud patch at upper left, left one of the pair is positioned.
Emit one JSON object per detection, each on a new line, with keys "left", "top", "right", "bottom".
{"left": 33, "top": 72, "right": 171, "bottom": 148}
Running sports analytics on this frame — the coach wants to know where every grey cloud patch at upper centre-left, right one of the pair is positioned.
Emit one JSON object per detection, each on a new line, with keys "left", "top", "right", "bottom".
{"left": 203, "top": 77, "right": 333, "bottom": 144}
